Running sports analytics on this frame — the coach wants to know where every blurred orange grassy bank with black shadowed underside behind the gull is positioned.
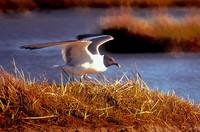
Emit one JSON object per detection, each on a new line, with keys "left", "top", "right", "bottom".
{"left": 101, "top": 13, "right": 200, "bottom": 52}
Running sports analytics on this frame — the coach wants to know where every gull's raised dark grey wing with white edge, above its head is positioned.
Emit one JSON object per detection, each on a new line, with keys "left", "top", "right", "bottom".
{"left": 78, "top": 35, "right": 114, "bottom": 54}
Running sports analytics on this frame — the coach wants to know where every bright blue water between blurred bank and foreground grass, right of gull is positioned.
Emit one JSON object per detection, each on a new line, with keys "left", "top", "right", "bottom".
{"left": 112, "top": 54, "right": 200, "bottom": 102}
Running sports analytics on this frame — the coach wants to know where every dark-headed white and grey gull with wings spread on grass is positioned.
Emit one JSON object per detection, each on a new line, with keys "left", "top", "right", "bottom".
{"left": 20, "top": 35, "right": 120, "bottom": 78}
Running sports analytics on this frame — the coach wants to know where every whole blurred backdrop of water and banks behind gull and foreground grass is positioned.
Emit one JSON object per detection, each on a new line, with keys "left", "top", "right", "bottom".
{"left": 0, "top": 0, "right": 200, "bottom": 103}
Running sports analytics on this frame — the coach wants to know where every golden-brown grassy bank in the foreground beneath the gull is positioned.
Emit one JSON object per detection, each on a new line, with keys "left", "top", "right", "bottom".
{"left": 0, "top": 69, "right": 200, "bottom": 131}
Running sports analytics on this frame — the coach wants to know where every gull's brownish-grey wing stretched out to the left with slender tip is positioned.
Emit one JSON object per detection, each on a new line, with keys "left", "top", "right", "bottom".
{"left": 21, "top": 40, "right": 92, "bottom": 66}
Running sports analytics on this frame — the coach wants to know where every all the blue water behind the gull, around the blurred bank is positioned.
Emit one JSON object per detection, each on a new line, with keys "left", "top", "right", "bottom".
{"left": 0, "top": 8, "right": 200, "bottom": 103}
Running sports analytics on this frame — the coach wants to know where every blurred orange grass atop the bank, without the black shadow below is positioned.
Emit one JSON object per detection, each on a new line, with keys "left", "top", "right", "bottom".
{"left": 101, "top": 13, "right": 200, "bottom": 51}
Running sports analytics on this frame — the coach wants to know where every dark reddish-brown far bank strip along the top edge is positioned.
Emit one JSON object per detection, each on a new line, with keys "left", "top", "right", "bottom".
{"left": 0, "top": 0, "right": 200, "bottom": 12}
